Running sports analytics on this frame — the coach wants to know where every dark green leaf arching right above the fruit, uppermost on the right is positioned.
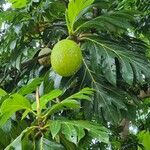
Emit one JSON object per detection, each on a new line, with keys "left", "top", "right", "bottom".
{"left": 75, "top": 11, "right": 133, "bottom": 32}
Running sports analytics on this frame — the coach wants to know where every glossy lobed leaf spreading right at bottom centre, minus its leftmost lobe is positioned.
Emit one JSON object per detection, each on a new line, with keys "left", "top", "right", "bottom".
{"left": 49, "top": 120, "right": 109, "bottom": 145}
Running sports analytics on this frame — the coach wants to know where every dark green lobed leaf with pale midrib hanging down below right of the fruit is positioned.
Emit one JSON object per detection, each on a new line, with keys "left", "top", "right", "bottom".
{"left": 81, "top": 61, "right": 136, "bottom": 123}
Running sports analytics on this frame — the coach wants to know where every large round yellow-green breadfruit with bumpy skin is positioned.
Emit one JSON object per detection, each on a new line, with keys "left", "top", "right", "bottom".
{"left": 51, "top": 39, "right": 82, "bottom": 77}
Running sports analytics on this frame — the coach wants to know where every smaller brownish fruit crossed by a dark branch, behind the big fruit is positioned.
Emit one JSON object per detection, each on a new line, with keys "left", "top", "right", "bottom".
{"left": 38, "top": 48, "right": 51, "bottom": 67}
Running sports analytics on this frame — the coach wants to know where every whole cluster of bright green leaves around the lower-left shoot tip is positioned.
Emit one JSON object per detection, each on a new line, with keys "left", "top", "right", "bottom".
{"left": 0, "top": 85, "right": 109, "bottom": 150}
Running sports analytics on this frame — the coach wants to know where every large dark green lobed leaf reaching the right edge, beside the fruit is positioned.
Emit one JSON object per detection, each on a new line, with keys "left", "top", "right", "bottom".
{"left": 82, "top": 36, "right": 150, "bottom": 85}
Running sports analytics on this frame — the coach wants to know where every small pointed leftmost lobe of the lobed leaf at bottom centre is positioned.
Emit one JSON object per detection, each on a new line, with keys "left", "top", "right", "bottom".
{"left": 50, "top": 121, "right": 61, "bottom": 139}
